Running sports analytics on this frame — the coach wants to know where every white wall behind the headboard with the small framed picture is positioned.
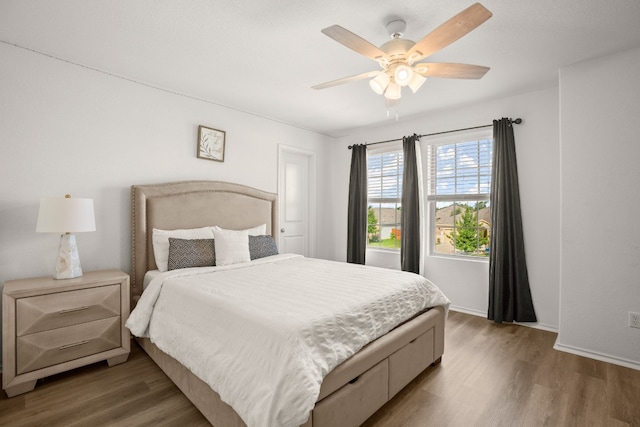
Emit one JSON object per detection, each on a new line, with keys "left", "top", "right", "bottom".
{"left": 0, "top": 44, "right": 332, "bottom": 368}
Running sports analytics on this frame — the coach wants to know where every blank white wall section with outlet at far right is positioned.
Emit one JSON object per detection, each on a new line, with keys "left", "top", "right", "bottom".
{"left": 556, "top": 49, "right": 640, "bottom": 369}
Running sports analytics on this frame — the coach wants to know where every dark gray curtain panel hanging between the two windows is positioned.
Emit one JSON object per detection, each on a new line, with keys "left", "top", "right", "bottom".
{"left": 400, "top": 134, "right": 420, "bottom": 273}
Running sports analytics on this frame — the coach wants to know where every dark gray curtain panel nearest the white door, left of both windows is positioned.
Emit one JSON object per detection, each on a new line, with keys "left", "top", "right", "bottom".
{"left": 347, "top": 144, "right": 367, "bottom": 264}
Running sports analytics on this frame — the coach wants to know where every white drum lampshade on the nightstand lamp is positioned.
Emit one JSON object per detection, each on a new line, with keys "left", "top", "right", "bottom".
{"left": 36, "top": 197, "right": 96, "bottom": 233}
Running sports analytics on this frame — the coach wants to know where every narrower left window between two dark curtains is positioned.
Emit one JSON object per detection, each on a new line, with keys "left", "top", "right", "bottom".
{"left": 367, "top": 150, "right": 403, "bottom": 250}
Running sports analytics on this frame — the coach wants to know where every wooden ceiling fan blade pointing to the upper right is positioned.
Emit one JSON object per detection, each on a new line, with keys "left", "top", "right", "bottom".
{"left": 406, "top": 3, "right": 493, "bottom": 63}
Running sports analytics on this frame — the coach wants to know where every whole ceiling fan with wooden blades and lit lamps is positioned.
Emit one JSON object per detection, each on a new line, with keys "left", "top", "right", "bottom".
{"left": 313, "top": 3, "right": 492, "bottom": 107}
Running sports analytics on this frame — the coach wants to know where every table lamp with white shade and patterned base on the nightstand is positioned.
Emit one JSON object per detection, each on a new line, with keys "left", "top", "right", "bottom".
{"left": 36, "top": 194, "right": 96, "bottom": 279}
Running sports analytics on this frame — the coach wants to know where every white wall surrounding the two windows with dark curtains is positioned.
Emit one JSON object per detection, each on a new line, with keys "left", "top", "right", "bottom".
{"left": 331, "top": 87, "right": 560, "bottom": 330}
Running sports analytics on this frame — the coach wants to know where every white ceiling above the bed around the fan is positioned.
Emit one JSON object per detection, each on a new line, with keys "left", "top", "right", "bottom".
{"left": 0, "top": 0, "right": 640, "bottom": 136}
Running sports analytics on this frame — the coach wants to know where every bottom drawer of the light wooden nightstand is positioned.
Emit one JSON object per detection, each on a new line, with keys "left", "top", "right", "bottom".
{"left": 16, "top": 316, "right": 121, "bottom": 374}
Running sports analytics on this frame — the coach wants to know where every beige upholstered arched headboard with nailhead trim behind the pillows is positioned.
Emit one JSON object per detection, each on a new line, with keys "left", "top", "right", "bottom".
{"left": 131, "top": 181, "right": 278, "bottom": 304}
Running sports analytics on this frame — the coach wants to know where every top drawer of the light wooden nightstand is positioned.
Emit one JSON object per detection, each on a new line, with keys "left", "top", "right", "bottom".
{"left": 16, "top": 284, "right": 120, "bottom": 336}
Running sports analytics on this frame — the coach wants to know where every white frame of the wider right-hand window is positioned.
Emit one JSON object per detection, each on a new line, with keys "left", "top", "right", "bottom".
{"left": 422, "top": 127, "right": 493, "bottom": 262}
